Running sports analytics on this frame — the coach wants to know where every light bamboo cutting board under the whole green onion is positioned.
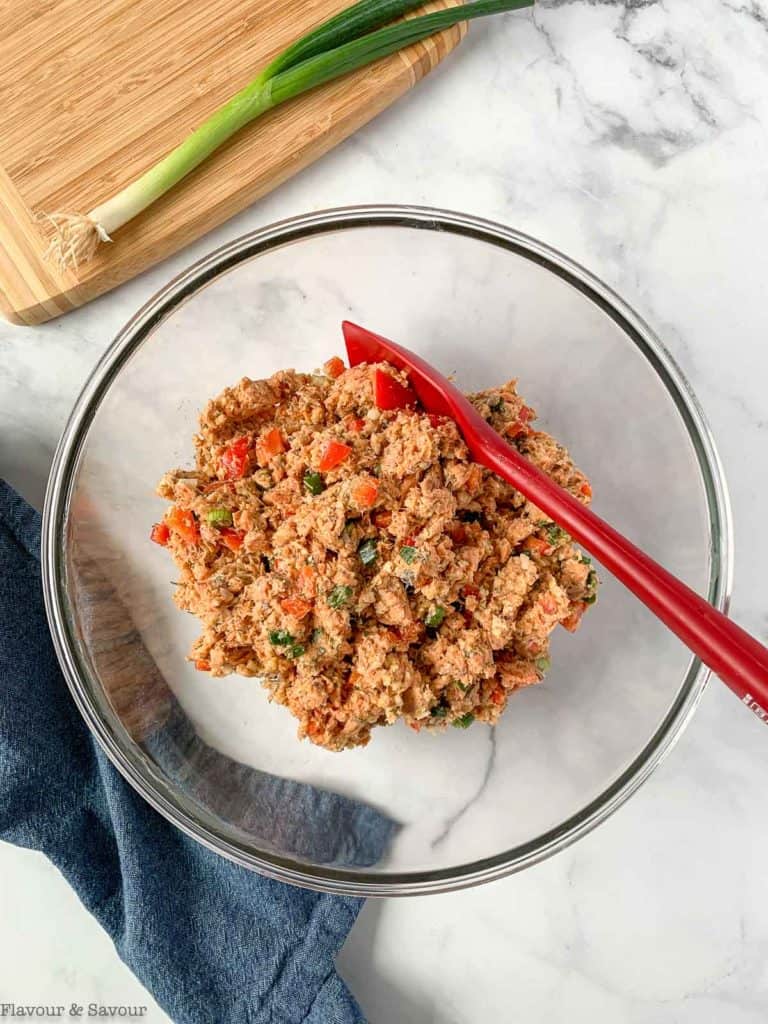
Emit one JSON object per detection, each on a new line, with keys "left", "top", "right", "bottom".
{"left": 0, "top": 0, "right": 464, "bottom": 324}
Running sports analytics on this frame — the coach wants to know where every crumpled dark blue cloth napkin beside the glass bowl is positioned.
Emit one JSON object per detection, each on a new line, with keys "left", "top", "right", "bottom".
{"left": 0, "top": 480, "right": 394, "bottom": 1024}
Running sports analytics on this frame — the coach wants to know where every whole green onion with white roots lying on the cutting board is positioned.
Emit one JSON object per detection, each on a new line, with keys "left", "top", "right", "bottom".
{"left": 48, "top": 0, "right": 532, "bottom": 269}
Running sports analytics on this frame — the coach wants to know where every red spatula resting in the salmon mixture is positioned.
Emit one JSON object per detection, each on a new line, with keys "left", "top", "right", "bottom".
{"left": 343, "top": 321, "right": 768, "bottom": 722}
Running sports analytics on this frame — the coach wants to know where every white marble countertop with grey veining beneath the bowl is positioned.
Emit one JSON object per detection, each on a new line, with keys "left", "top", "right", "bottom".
{"left": 0, "top": 0, "right": 768, "bottom": 1024}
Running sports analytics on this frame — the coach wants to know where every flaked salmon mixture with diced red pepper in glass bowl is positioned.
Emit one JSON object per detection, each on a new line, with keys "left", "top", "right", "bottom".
{"left": 153, "top": 358, "right": 597, "bottom": 751}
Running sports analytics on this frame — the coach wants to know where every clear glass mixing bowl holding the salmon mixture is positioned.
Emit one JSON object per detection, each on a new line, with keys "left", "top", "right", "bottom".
{"left": 43, "top": 207, "right": 731, "bottom": 895}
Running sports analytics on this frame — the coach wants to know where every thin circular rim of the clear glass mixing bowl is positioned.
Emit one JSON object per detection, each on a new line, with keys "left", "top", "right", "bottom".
{"left": 42, "top": 205, "right": 733, "bottom": 896}
